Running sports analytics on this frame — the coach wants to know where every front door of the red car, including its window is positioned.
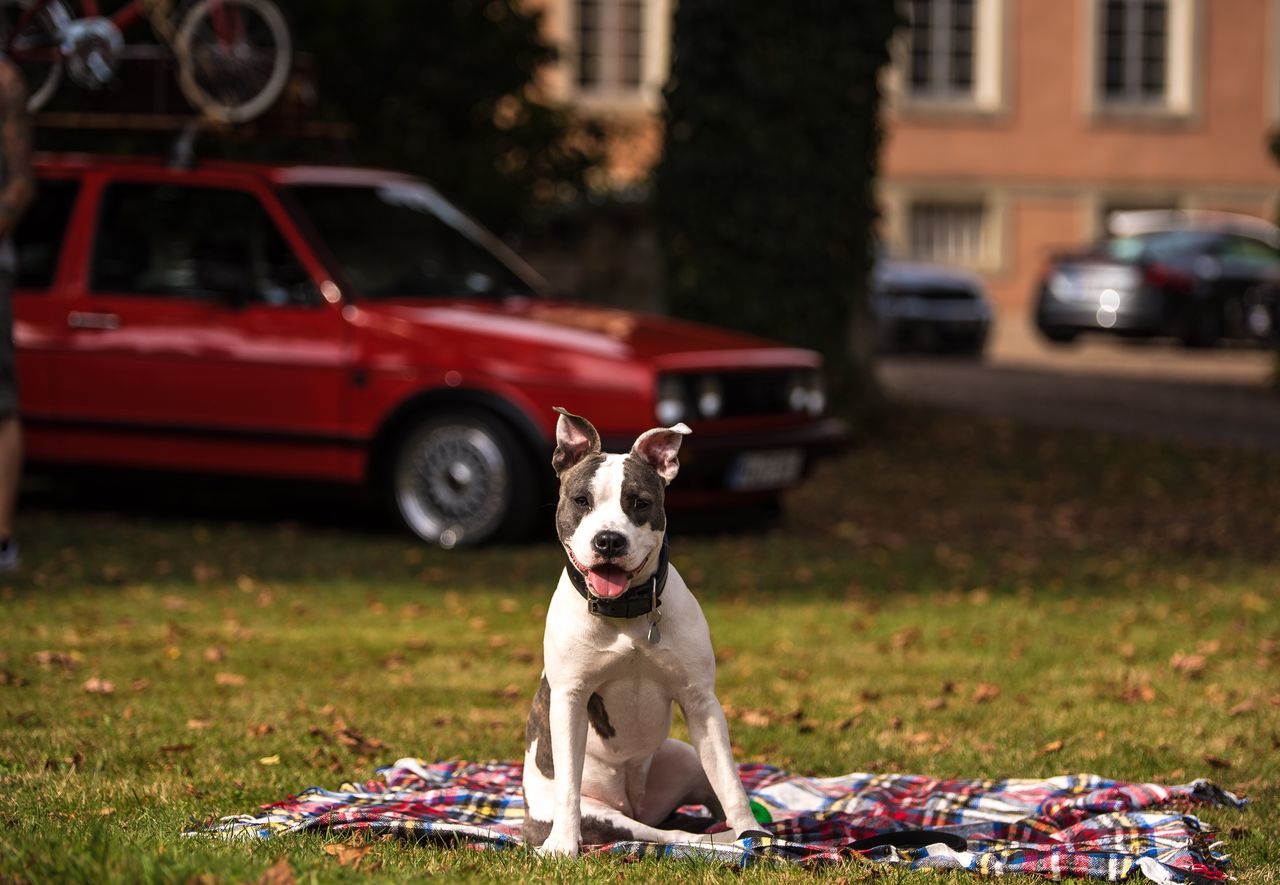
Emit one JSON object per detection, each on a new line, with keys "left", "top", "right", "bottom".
{"left": 54, "top": 170, "right": 353, "bottom": 479}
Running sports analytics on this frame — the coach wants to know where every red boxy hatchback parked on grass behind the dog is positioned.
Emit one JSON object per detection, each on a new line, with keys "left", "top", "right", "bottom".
{"left": 14, "top": 156, "right": 842, "bottom": 547}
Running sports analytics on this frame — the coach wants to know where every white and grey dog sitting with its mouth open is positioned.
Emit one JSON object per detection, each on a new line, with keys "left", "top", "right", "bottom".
{"left": 524, "top": 409, "right": 758, "bottom": 857}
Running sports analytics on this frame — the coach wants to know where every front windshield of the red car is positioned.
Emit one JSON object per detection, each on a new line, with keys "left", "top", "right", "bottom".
{"left": 289, "top": 181, "right": 535, "bottom": 298}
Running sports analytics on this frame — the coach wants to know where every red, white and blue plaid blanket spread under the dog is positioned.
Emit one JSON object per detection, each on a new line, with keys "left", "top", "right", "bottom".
{"left": 197, "top": 758, "right": 1244, "bottom": 882}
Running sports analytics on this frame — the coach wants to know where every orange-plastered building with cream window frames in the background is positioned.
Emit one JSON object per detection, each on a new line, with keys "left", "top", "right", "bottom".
{"left": 539, "top": 0, "right": 1280, "bottom": 313}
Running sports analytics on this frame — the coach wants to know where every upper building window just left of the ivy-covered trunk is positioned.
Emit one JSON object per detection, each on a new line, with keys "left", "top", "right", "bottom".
{"left": 573, "top": 0, "right": 648, "bottom": 95}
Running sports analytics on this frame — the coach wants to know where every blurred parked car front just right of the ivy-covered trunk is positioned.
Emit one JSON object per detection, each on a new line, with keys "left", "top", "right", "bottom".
{"left": 872, "top": 257, "right": 992, "bottom": 356}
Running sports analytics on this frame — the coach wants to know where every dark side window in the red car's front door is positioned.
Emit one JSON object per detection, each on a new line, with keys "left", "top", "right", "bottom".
{"left": 91, "top": 183, "right": 323, "bottom": 307}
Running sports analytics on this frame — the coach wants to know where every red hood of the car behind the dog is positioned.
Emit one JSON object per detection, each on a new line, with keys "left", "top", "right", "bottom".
{"left": 355, "top": 297, "right": 819, "bottom": 369}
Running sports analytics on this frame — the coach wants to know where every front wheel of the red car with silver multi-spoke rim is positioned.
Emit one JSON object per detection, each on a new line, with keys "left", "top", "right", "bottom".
{"left": 387, "top": 411, "right": 535, "bottom": 548}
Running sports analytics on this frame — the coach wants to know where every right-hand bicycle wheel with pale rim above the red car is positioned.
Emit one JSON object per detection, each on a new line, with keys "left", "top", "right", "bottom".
{"left": 174, "top": 0, "right": 293, "bottom": 123}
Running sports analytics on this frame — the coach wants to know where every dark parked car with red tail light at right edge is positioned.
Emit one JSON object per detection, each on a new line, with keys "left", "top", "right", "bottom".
{"left": 1036, "top": 213, "right": 1280, "bottom": 347}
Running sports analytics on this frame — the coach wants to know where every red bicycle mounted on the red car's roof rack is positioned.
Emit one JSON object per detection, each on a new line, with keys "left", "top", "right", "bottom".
{"left": 0, "top": 0, "right": 293, "bottom": 123}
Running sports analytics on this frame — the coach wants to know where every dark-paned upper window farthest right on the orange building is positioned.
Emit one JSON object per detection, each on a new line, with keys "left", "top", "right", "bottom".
{"left": 1100, "top": 0, "right": 1169, "bottom": 105}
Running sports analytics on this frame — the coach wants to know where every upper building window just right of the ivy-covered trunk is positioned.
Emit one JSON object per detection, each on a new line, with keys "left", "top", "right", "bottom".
{"left": 906, "top": 0, "right": 977, "bottom": 100}
